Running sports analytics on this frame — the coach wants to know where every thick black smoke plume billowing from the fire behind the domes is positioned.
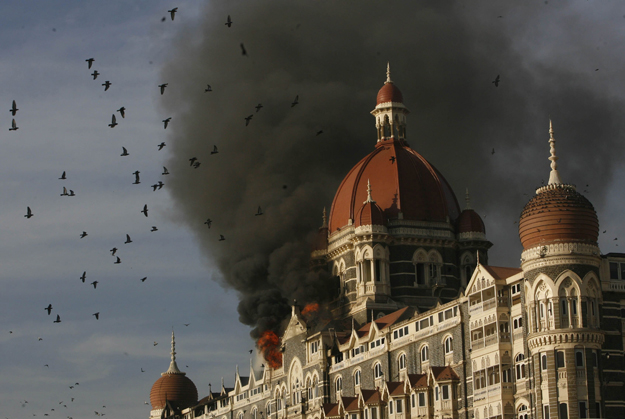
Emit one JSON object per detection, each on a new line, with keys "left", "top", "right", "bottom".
{"left": 161, "top": 0, "right": 625, "bottom": 336}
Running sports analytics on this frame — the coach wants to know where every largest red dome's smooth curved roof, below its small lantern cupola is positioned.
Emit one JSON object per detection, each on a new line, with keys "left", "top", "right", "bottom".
{"left": 329, "top": 139, "right": 460, "bottom": 234}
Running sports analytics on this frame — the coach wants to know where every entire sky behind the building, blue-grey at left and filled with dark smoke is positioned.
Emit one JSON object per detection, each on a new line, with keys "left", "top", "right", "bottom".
{"left": 0, "top": 0, "right": 625, "bottom": 418}
